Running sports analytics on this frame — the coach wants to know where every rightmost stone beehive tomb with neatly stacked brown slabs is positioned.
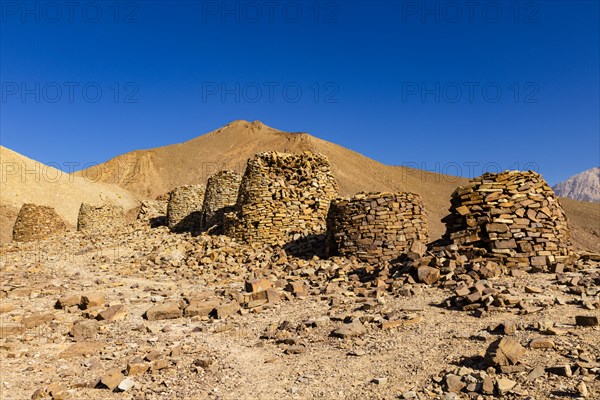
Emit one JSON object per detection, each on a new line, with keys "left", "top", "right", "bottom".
{"left": 443, "top": 171, "right": 572, "bottom": 270}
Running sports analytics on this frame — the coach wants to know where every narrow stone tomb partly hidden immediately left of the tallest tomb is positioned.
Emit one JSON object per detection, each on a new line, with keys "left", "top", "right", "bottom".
{"left": 202, "top": 171, "right": 242, "bottom": 231}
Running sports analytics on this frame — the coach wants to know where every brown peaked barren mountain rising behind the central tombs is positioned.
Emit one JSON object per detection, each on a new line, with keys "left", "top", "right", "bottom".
{"left": 76, "top": 120, "right": 600, "bottom": 250}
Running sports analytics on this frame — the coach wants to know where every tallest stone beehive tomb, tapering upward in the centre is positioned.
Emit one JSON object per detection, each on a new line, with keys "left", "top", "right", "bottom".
{"left": 224, "top": 152, "right": 338, "bottom": 246}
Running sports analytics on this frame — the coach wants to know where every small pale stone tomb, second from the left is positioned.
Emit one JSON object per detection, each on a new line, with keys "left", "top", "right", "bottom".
{"left": 77, "top": 203, "right": 127, "bottom": 234}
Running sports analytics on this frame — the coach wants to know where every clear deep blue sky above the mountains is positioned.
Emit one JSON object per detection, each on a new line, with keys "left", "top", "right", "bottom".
{"left": 0, "top": 0, "right": 600, "bottom": 184}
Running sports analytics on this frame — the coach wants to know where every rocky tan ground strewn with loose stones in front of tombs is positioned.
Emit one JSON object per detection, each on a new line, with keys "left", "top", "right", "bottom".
{"left": 0, "top": 224, "right": 600, "bottom": 399}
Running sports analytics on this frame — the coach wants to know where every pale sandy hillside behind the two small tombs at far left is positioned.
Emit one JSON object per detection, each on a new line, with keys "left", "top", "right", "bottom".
{"left": 0, "top": 146, "right": 140, "bottom": 242}
